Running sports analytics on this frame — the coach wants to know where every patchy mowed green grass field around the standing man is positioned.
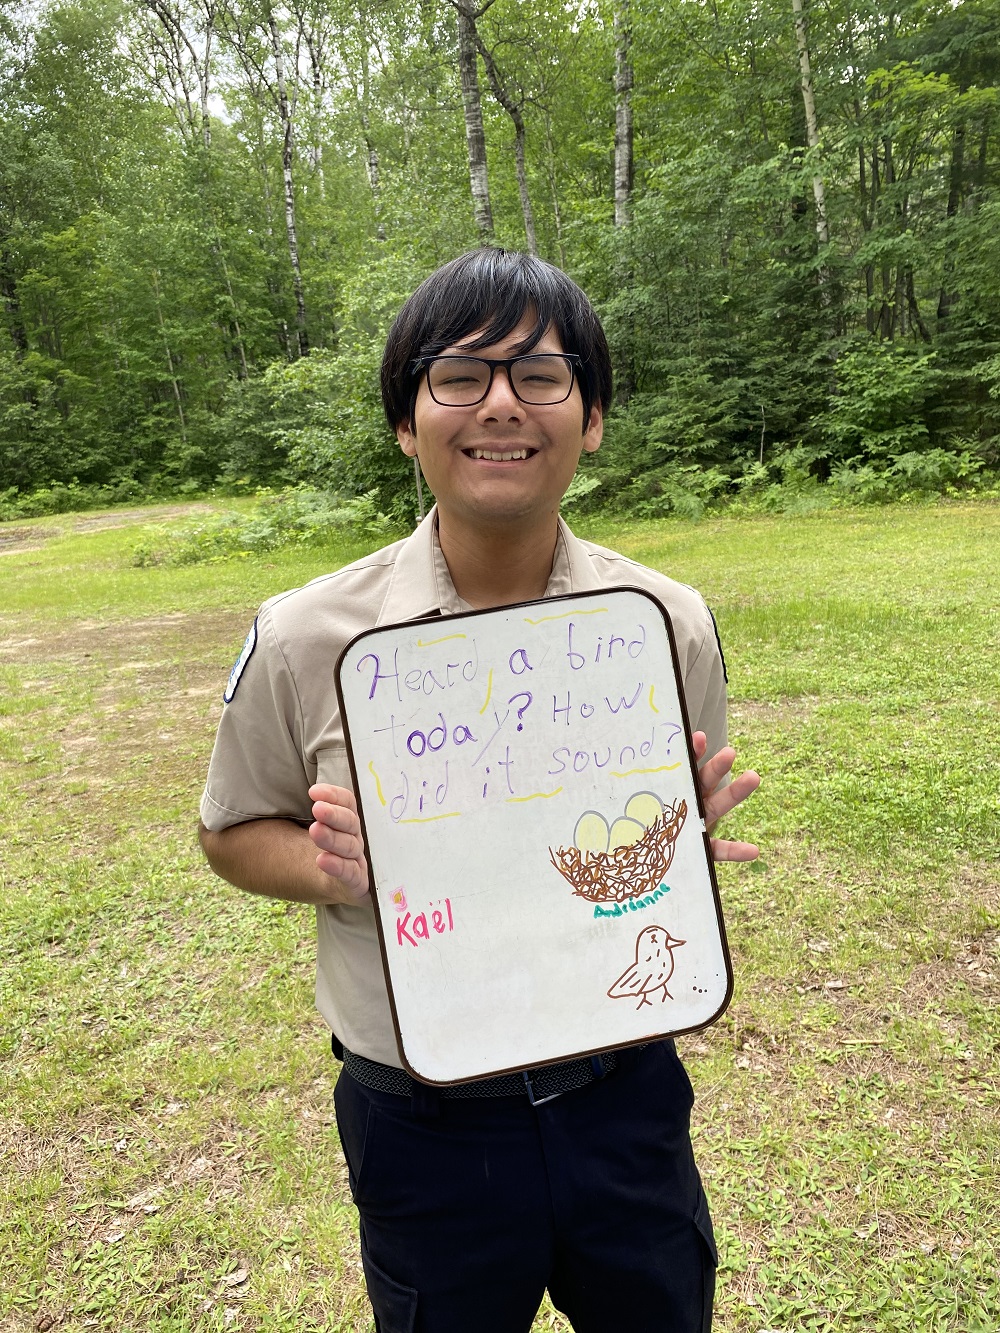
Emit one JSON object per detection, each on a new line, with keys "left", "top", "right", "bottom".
{"left": 0, "top": 504, "right": 1000, "bottom": 1333}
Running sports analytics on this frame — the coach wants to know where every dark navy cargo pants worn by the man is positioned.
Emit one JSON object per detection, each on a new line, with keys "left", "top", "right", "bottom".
{"left": 335, "top": 1041, "right": 716, "bottom": 1333}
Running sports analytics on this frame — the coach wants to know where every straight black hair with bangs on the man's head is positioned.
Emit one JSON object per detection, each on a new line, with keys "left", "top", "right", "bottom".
{"left": 381, "top": 245, "right": 612, "bottom": 431}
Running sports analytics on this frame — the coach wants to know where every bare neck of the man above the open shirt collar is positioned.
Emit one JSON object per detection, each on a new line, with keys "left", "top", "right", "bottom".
{"left": 437, "top": 513, "right": 559, "bottom": 611}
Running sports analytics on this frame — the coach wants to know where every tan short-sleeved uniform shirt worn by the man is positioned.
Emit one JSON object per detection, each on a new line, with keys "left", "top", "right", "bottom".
{"left": 201, "top": 509, "right": 725, "bottom": 1066}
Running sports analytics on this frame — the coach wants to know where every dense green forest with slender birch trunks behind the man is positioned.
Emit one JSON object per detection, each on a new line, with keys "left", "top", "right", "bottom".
{"left": 0, "top": 0, "right": 1000, "bottom": 523}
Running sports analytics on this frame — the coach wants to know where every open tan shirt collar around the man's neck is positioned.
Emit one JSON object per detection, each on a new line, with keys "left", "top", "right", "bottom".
{"left": 376, "top": 505, "right": 600, "bottom": 625}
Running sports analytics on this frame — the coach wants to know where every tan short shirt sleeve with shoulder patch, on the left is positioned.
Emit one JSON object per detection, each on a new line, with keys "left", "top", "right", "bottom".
{"left": 201, "top": 605, "right": 316, "bottom": 832}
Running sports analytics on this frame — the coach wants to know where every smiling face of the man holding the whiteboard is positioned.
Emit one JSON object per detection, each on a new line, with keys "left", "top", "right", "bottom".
{"left": 396, "top": 316, "right": 604, "bottom": 532}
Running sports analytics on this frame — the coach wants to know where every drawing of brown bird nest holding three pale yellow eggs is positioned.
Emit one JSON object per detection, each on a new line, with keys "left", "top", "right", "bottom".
{"left": 548, "top": 792, "right": 688, "bottom": 902}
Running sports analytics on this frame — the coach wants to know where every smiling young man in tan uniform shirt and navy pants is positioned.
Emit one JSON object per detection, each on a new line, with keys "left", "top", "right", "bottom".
{"left": 201, "top": 249, "right": 757, "bottom": 1333}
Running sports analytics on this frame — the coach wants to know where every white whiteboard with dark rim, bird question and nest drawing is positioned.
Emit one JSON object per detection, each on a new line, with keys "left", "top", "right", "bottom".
{"left": 337, "top": 588, "right": 732, "bottom": 1082}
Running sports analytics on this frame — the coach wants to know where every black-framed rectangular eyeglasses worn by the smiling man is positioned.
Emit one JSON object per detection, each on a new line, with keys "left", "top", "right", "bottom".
{"left": 413, "top": 352, "right": 583, "bottom": 408}
